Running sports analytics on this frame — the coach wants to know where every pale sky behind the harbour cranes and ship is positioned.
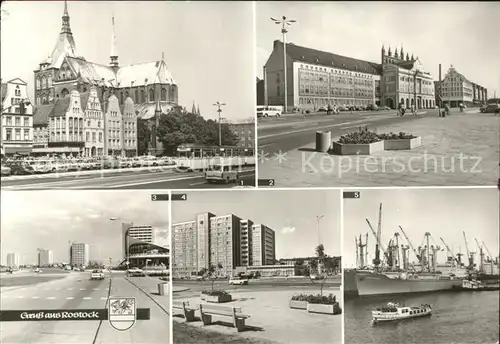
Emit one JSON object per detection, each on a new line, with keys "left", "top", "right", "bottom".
{"left": 343, "top": 188, "right": 500, "bottom": 268}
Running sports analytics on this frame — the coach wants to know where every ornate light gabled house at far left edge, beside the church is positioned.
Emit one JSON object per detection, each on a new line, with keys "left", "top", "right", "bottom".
{"left": 0, "top": 79, "right": 33, "bottom": 155}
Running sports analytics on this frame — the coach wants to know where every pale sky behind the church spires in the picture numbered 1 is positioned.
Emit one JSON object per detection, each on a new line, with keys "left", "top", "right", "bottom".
{"left": 1, "top": 1, "right": 256, "bottom": 122}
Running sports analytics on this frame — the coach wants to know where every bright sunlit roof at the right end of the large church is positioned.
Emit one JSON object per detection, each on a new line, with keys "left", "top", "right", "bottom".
{"left": 116, "top": 61, "right": 175, "bottom": 87}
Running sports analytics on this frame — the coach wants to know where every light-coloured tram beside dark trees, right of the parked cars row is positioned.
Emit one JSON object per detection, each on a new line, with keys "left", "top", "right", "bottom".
{"left": 176, "top": 144, "right": 256, "bottom": 171}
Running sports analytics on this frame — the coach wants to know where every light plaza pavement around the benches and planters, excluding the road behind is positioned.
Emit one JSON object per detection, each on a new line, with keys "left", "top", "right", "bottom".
{"left": 172, "top": 288, "right": 342, "bottom": 344}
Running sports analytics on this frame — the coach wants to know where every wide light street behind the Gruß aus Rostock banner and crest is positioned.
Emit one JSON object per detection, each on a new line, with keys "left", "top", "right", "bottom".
{"left": 0, "top": 272, "right": 170, "bottom": 344}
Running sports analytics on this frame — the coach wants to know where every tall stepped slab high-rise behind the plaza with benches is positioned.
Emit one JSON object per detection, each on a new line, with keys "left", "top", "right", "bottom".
{"left": 172, "top": 213, "right": 275, "bottom": 277}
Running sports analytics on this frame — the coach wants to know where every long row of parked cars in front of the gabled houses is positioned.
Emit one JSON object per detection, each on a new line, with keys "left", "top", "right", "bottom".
{"left": 2, "top": 156, "right": 175, "bottom": 176}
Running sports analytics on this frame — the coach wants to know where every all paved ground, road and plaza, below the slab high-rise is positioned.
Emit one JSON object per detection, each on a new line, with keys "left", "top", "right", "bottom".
{"left": 173, "top": 278, "right": 342, "bottom": 344}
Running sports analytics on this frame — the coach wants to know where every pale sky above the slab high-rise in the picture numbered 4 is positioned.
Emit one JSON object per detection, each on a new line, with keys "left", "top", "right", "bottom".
{"left": 172, "top": 190, "right": 341, "bottom": 259}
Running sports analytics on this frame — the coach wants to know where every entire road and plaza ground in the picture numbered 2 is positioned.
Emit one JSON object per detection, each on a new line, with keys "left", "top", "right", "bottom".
{"left": 259, "top": 109, "right": 500, "bottom": 187}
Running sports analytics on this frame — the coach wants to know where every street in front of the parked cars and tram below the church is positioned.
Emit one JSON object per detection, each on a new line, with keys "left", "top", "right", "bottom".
{"left": 1, "top": 168, "right": 255, "bottom": 190}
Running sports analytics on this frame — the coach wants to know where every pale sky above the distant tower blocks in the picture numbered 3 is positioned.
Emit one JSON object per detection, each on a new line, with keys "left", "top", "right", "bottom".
{"left": 1, "top": 190, "right": 170, "bottom": 264}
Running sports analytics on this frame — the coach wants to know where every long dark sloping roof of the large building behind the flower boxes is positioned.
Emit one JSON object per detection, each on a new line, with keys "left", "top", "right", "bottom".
{"left": 274, "top": 41, "right": 382, "bottom": 75}
